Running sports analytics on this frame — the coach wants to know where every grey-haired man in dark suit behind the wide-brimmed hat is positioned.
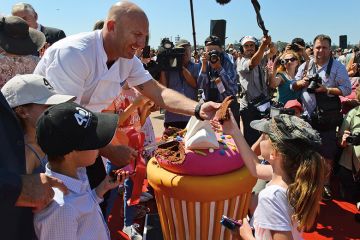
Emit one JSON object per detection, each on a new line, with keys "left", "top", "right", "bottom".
{"left": 11, "top": 3, "right": 66, "bottom": 45}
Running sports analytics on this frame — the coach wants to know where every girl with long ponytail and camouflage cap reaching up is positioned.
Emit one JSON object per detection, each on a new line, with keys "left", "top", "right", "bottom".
{"left": 213, "top": 113, "right": 325, "bottom": 240}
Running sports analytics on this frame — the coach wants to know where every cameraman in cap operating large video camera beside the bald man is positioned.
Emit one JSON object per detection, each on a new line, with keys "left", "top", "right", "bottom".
{"left": 160, "top": 39, "right": 200, "bottom": 129}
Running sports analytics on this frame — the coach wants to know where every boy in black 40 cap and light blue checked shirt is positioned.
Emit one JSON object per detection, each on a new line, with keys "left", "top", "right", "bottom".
{"left": 34, "top": 102, "right": 128, "bottom": 240}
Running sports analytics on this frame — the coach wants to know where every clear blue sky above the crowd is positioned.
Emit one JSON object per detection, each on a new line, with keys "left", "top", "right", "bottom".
{"left": 0, "top": 0, "right": 360, "bottom": 46}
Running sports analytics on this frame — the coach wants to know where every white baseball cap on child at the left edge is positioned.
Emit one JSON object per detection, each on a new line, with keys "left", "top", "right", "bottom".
{"left": 1, "top": 74, "right": 76, "bottom": 108}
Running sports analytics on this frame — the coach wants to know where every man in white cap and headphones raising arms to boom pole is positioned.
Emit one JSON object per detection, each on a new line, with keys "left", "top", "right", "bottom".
{"left": 237, "top": 36, "right": 277, "bottom": 145}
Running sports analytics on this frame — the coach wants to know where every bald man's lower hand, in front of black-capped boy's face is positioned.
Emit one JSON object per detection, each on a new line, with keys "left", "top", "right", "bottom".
{"left": 100, "top": 143, "right": 138, "bottom": 167}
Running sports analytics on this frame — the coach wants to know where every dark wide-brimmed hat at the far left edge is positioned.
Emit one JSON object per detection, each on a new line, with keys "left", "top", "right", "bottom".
{"left": 0, "top": 16, "right": 46, "bottom": 55}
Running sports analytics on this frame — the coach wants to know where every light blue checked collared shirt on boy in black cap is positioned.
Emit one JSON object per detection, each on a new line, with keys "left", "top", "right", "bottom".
{"left": 34, "top": 165, "right": 110, "bottom": 240}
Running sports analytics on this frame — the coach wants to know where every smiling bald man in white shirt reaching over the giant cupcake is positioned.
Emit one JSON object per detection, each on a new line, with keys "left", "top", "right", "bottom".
{"left": 34, "top": 1, "right": 219, "bottom": 166}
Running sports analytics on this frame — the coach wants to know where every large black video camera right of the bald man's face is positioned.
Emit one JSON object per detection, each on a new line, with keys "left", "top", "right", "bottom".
{"left": 156, "top": 38, "right": 185, "bottom": 71}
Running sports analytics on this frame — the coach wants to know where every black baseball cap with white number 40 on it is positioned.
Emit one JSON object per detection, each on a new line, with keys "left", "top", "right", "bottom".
{"left": 36, "top": 102, "right": 118, "bottom": 156}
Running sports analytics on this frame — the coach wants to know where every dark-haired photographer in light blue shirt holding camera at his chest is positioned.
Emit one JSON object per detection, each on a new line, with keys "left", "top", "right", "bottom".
{"left": 291, "top": 35, "right": 351, "bottom": 200}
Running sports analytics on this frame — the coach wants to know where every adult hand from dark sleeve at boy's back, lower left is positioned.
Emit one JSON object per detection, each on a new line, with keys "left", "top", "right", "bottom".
{"left": 15, "top": 173, "right": 68, "bottom": 211}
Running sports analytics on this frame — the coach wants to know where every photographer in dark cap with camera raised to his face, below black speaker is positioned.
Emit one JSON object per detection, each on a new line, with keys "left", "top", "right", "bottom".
{"left": 198, "top": 36, "right": 240, "bottom": 124}
